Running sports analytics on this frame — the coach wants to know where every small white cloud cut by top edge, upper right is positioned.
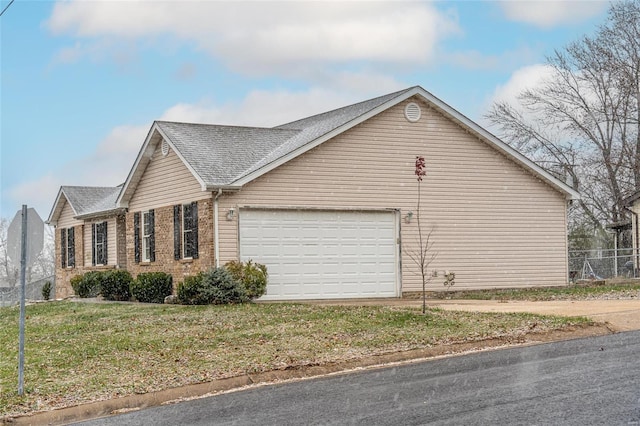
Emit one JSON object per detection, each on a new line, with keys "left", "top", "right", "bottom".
{"left": 498, "top": 0, "right": 609, "bottom": 28}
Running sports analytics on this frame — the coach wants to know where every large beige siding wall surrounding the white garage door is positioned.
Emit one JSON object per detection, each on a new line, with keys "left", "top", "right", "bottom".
{"left": 220, "top": 98, "right": 567, "bottom": 292}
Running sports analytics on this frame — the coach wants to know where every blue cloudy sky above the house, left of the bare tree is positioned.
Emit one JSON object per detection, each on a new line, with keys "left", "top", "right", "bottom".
{"left": 0, "top": 0, "right": 608, "bottom": 220}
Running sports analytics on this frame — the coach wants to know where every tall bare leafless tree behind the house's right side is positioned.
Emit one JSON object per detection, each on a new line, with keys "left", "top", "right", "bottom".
{"left": 487, "top": 0, "right": 640, "bottom": 232}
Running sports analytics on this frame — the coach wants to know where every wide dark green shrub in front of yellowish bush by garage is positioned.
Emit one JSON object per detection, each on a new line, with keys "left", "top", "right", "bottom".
{"left": 178, "top": 268, "right": 249, "bottom": 305}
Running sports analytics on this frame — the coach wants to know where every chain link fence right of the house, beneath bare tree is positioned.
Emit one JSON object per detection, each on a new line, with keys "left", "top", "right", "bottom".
{"left": 569, "top": 249, "right": 640, "bottom": 282}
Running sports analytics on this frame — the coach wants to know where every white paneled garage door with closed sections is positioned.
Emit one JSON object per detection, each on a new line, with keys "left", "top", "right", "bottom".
{"left": 239, "top": 209, "right": 398, "bottom": 300}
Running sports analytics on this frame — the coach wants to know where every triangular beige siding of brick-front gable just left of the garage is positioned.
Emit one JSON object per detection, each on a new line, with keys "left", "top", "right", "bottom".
{"left": 129, "top": 143, "right": 208, "bottom": 211}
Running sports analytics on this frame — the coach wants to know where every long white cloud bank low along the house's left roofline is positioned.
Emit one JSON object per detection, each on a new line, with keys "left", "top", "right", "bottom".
{"left": 4, "top": 83, "right": 405, "bottom": 219}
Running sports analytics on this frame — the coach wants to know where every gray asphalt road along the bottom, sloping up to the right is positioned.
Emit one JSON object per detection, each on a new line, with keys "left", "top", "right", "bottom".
{"left": 76, "top": 331, "right": 640, "bottom": 426}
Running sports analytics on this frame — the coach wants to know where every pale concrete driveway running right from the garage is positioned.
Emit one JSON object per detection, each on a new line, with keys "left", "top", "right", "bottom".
{"left": 428, "top": 299, "right": 640, "bottom": 331}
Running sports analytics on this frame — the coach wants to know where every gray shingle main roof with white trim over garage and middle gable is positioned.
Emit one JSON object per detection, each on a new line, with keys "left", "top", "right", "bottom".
{"left": 112, "top": 86, "right": 579, "bottom": 207}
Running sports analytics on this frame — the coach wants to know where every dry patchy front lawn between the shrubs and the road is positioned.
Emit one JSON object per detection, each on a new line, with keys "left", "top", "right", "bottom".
{"left": 0, "top": 301, "right": 591, "bottom": 417}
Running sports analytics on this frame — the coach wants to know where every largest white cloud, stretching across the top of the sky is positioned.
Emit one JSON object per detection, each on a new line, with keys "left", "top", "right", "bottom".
{"left": 47, "top": 1, "right": 460, "bottom": 75}
